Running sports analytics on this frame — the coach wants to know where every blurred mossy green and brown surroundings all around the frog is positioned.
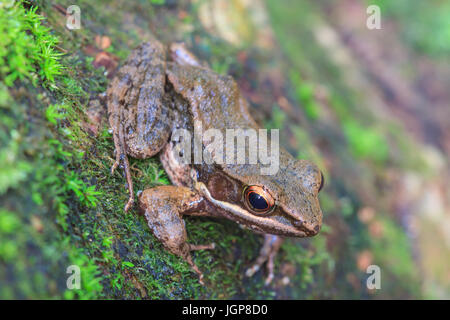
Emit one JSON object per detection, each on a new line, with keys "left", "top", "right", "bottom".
{"left": 0, "top": 0, "right": 450, "bottom": 299}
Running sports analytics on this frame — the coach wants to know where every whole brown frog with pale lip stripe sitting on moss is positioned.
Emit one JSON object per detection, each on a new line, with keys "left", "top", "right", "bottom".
{"left": 106, "top": 39, "right": 324, "bottom": 284}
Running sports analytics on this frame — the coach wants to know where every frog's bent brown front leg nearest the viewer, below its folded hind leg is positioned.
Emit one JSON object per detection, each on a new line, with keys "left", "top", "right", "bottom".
{"left": 139, "top": 186, "right": 214, "bottom": 284}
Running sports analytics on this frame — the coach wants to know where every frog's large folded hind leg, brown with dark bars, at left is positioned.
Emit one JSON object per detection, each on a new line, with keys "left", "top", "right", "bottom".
{"left": 107, "top": 41, "right": 173, "bottom": 211}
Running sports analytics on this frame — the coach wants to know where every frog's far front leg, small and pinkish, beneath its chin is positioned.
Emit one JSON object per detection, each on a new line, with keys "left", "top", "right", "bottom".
{"left": 245, "top": 234, "right": 283, "bottom": 285}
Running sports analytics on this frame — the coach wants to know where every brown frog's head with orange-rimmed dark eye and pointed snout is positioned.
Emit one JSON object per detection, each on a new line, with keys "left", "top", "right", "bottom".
{"left": 203, "top": 151, "right": 324, "bottom": 237}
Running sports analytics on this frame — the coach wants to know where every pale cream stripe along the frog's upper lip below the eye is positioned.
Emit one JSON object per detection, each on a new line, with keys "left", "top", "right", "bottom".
{"left": 197, "top": 183, "right": 315, "bottom": 238}
